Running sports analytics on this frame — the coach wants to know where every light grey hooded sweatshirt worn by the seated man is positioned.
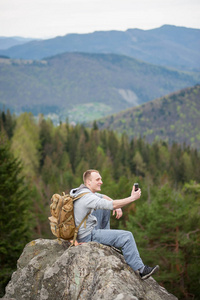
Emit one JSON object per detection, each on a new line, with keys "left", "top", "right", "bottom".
{"left": 70, "top": 184, "right": 113, "bottom": 239}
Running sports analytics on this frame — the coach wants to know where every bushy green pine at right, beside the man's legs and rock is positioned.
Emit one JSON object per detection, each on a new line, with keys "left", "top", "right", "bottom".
{"left": 126, "top": 184, "right": 200, "bottom": 299}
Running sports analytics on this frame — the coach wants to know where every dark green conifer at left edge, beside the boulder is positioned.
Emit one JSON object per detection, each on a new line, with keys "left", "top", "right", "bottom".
{"left": 0, "top": 135, "right": 31, "bottom": 295}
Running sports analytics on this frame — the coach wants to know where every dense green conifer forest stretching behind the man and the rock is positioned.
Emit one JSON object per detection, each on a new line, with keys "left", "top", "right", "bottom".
{"left": 0, "top": 111, "right": 200, "bottom": 300}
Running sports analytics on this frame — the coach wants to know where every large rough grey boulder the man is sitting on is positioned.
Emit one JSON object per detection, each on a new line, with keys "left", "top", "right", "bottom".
{"left": 2, "top": 239, "right": 177, "bottom": 300}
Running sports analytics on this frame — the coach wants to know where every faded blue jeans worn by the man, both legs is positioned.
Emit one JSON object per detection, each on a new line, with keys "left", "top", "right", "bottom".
{"left": 78, "top": 209, "right": 144, "bottom": 271}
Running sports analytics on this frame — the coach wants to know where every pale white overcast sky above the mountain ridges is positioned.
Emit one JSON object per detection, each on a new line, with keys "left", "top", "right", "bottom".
{"left": 0, "top": 0, "right": 200, "bottom": 38}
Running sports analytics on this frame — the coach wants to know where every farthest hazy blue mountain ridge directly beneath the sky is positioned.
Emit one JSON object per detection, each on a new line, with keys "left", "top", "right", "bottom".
{"left": 0, "top": 25, "right": 200, "bottom": 71}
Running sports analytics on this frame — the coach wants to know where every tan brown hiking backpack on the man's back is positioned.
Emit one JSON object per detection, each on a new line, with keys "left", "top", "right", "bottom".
{"left": 49, "top": 193, "right": 91, "bottom": 245}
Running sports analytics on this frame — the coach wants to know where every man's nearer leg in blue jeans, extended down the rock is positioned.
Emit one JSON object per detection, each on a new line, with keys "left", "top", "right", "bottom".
{"left": 92, "top": 229, "right": 144, "bottom": 271}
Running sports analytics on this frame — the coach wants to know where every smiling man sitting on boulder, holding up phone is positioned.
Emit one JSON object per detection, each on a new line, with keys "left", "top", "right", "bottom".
{"left": 70, "top": 170, "right": 159, "bottom": 279}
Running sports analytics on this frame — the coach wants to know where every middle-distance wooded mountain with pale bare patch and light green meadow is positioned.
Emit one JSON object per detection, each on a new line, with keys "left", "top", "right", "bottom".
{"left": 0, "top": 53, "right": 200, "bottom": 122}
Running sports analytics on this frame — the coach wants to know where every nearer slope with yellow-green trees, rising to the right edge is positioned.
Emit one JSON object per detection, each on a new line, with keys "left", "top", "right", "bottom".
{"left": 94, "top": 85, "right": 200, "bottom": 149}
